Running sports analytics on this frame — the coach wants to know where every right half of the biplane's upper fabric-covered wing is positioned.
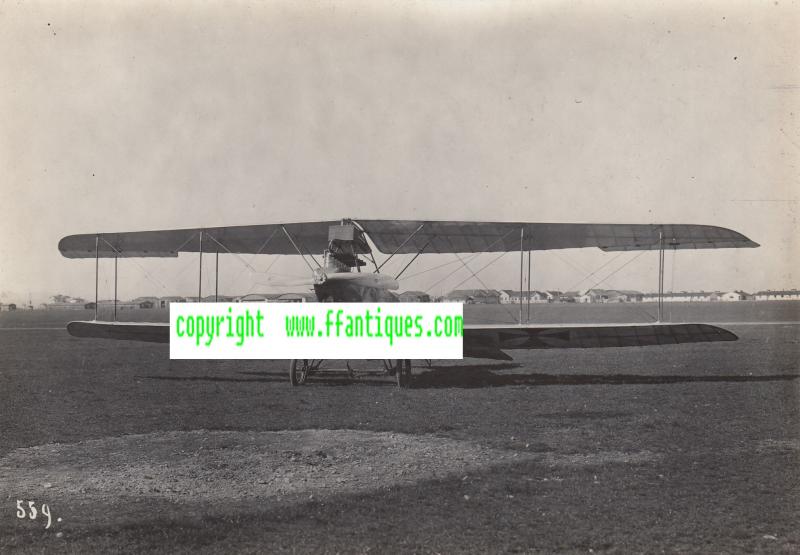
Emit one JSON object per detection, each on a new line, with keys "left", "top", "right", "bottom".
{"left": 357, "top": 220, "right": 758, "bottom": 254}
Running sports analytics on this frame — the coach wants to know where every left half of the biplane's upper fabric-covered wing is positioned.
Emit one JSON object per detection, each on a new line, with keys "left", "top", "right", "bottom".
{"left": 58, "top": 221, "right": 339, "bottom": 258}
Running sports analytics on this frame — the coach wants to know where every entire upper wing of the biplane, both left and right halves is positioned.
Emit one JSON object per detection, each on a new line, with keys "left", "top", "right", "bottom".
{"left": 58, "top": 220, "right": 758, "bottom": 258}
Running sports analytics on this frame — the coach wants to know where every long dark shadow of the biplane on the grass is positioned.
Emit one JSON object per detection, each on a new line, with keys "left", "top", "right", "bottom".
{"left": 137, "top": 362, "right": 800, "bottom": 389}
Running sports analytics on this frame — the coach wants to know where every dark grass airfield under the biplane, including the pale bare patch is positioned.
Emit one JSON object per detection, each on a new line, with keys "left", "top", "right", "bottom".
{"left": 0, "top": 302, "right": 800, "bottom": 553}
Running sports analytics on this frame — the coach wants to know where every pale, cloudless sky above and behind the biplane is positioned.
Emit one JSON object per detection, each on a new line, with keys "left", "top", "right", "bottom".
{"left": 0, "top": 0, "right": 800, "bottom": 303}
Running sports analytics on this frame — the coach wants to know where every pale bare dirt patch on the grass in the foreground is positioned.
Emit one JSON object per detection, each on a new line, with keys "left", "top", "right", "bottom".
{"left": 0, "top": 430, "right": 655, "bottom": 503}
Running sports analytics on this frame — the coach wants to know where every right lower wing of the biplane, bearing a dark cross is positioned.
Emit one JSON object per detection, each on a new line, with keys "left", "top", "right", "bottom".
{"left": 464, "top": 324, "right": 738, "bottom": 360}
